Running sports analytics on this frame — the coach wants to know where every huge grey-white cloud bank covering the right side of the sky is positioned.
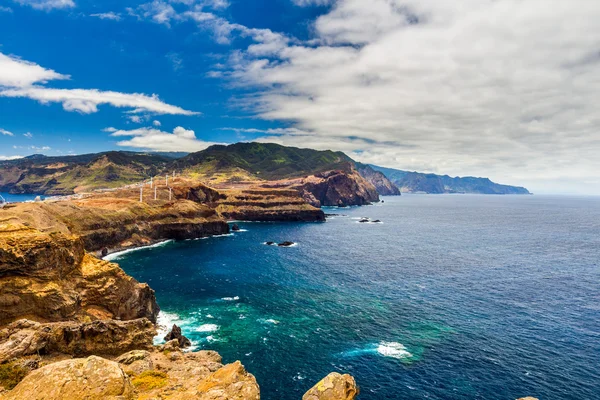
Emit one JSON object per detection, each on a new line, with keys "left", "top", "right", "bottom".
{"left": 217, "top": 0, "right": 600, "bottom": 194}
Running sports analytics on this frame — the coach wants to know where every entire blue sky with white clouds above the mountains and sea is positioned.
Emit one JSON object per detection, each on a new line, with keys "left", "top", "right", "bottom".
{"left": 0, "top": 0, "right": 600, "bottom": 194}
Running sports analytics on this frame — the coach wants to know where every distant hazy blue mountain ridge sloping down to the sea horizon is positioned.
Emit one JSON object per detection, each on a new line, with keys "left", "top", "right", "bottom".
{"left": 370, "top": 165, "right": 530, "bottom": 194}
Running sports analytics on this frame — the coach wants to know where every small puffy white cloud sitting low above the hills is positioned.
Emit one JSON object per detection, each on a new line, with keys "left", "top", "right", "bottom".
{"left": 109, "top": 126, "right": 215, "bottom": 152}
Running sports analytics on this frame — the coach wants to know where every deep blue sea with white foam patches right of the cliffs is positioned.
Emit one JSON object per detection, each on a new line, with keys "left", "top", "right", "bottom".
{"left": 116, "top": 195, "right": 600, "bottom": 400}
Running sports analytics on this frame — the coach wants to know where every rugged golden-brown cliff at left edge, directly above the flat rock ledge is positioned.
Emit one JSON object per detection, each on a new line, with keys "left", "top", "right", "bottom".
{"left": 0, "top": 225, "right": 159, "bottom": 326}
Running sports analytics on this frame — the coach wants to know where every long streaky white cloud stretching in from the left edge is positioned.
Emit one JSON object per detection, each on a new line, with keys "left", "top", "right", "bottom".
{"left": 0, "top": 53, "right": 198, "bottom": 115}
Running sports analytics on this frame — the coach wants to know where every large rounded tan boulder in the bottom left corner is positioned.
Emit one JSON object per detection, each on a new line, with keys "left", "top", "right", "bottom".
{"left": 2, "top": 356, "right": 134, "bottom": 400}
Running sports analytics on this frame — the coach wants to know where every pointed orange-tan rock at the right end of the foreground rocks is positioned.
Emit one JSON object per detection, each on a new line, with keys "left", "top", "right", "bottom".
{"left": 198, "top": 361, "right": 260, "bottom": 400}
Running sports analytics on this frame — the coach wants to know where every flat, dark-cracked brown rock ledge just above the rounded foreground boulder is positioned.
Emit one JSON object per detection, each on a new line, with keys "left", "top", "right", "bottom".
{"left": 0, "top": 318, "right": 156, "bottom": 363}
